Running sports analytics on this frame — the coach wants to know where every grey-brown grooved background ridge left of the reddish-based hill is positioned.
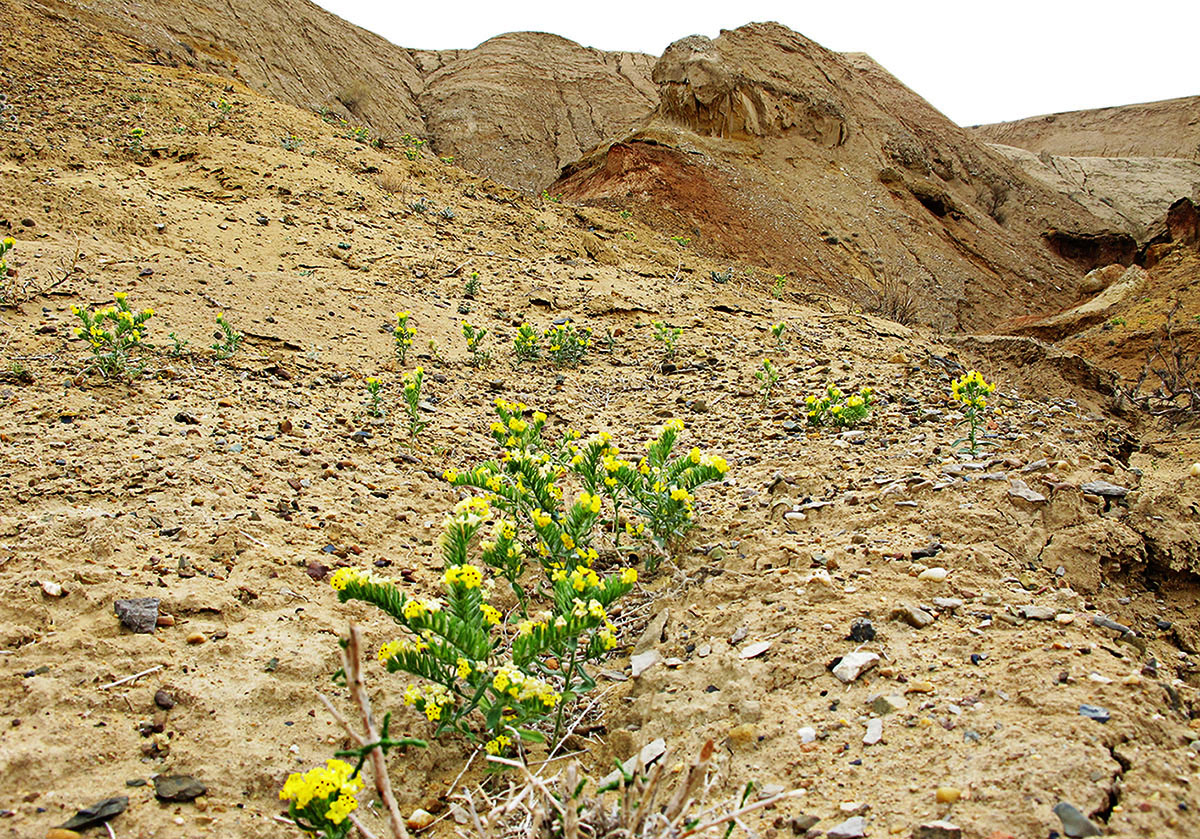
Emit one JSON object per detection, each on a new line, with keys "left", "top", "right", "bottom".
{"left": 37, "top": 0, "right": 658, "bottom": 190}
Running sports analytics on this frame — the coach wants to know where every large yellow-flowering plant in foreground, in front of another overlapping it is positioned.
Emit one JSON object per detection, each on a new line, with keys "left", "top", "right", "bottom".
{"left": 330, "top": 489, "right": 637, "bottom": 754}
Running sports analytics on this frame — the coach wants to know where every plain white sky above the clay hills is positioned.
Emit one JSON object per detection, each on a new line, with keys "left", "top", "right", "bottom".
{"left": 317, "top": 0, "right": 1200, "bottom": 125}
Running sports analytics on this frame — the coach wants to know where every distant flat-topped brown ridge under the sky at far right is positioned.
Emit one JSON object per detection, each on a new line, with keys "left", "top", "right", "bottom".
{"left": 972, "top": 96, "right": 1200, "bottom": 160}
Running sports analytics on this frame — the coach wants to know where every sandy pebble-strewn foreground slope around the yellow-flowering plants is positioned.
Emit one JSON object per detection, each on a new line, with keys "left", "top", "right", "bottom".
{"left": 0, "top": 4, "right": 1200, "bottom": 839}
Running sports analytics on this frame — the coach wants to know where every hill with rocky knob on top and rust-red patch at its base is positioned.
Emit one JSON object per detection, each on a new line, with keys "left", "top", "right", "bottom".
{"left": 552, "top": 24, "right": 1123, "bottom": 329}
